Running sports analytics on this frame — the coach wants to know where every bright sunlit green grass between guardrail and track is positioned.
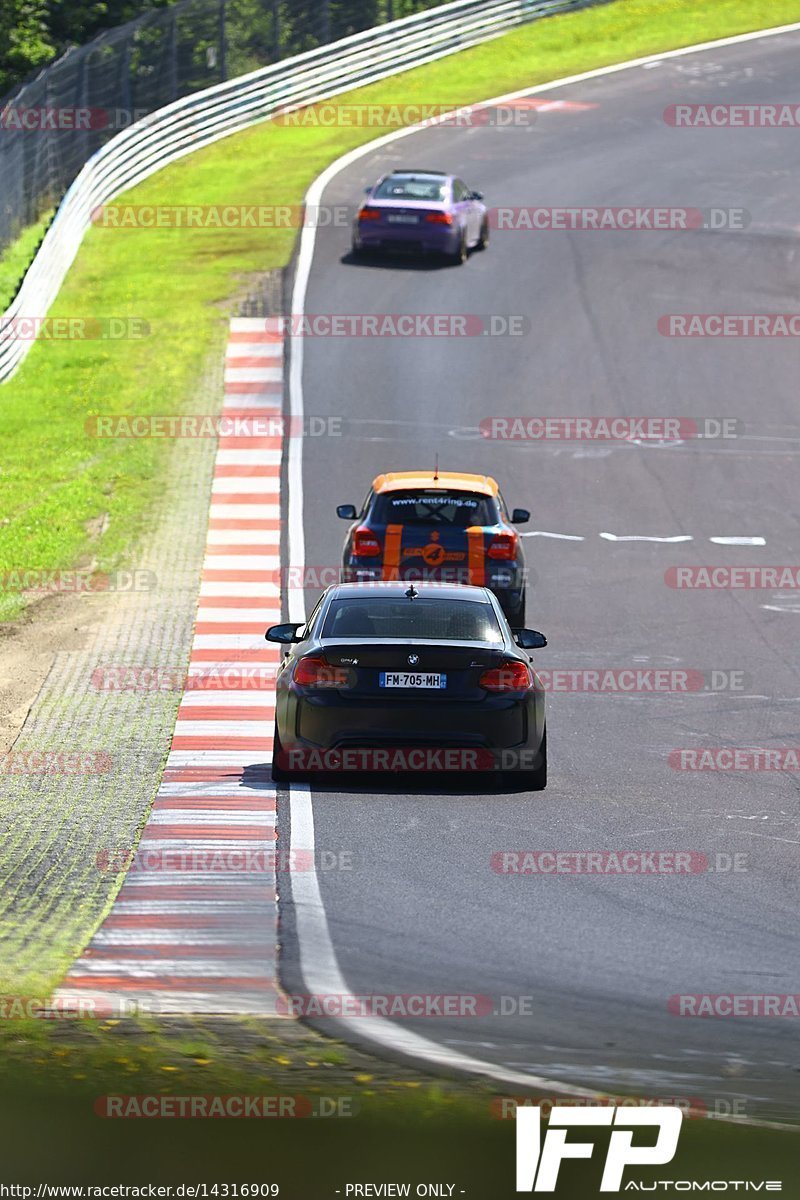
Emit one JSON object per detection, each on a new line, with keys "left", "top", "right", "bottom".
{"left": 0, "top": 0, "right": 800, "bottom": 619}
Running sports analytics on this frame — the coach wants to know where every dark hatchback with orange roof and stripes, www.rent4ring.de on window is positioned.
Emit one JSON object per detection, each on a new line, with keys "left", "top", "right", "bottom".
{"left": 336, "top": 470, "right": 530, "bottom": 628}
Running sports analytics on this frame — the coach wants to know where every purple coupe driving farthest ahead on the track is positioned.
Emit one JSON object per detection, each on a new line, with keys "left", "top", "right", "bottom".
{"left": 353, "top": 170, "right": 489, "bottom": 263}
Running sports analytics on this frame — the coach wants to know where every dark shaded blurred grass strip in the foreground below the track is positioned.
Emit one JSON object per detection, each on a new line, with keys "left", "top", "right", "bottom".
{"left": 0, "top": 1016, "right": 798, "bottom": 1185}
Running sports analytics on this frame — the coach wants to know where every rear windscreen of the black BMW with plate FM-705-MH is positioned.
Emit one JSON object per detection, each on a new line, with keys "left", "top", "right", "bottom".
{"left": 323, "top": 596, "right": 503, "bottom": 642}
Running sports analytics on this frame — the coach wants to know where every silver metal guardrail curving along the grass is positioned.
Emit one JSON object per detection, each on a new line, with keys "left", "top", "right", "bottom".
{"left": 0, "top": 0, "right": 607, "bottom": 382}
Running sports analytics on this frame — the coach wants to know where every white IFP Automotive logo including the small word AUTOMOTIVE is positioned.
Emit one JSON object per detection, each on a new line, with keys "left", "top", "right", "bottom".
{"left": 516, "top": 1104, "right": 783, "bottom": 1195}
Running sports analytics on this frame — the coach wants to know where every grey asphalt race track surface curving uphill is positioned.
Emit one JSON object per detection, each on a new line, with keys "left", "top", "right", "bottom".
{"left": 278, "top": 32, "right": 800, "bottom": 1116}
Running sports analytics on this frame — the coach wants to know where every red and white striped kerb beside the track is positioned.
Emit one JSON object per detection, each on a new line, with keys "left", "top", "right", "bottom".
{"left": 54, "top": 318, "right": 291, "bottom": 1016}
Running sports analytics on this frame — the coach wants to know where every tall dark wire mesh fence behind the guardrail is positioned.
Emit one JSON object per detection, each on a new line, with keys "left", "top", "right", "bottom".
{"left": 0, "top": 0, "right": 440, "bottom": 250}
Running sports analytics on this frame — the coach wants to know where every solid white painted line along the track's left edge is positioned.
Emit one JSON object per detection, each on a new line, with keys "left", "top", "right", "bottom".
{"left": 287, "top": 14, "right": 800, "bottom": 1108}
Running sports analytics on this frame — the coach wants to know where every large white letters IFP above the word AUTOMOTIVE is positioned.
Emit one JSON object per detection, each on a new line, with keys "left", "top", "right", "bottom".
{"left": 517, "top": 1104, "right": 684, "bottom": 1192}
